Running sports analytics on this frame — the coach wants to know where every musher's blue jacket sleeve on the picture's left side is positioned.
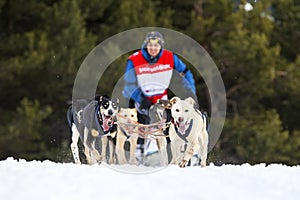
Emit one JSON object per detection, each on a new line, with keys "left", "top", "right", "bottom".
{"left": 122, "top": 60, "right": 142, "bottom": 103}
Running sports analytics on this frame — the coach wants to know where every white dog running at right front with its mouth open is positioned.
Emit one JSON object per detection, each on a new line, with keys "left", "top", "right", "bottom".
{"left": 170, "top": 97, "right": 208, "bottom": 167}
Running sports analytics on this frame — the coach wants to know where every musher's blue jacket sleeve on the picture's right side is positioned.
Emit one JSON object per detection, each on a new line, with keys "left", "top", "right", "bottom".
{"left": 174, "top": 54, "right": 196, "bottom": 94}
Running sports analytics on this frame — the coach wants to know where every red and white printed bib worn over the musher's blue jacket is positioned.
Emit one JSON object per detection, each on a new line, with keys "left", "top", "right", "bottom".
{"left": 129, "top": 50, "right": 174, "bottom": 104}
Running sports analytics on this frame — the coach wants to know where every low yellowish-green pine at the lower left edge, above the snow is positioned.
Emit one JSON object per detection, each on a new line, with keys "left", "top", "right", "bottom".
{"left": 0, "top": 98, "right": 52, "bottom": 159}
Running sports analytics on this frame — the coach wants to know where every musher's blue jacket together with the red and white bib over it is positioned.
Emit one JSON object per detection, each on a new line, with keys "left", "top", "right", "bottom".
{"left": 123, "top": 48, "right": 196, "bottom": 104}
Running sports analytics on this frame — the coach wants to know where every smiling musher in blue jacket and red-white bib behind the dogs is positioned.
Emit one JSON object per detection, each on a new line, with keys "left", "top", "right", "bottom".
{"left": 123, "top": 31, "right": 197, "bottom": 162}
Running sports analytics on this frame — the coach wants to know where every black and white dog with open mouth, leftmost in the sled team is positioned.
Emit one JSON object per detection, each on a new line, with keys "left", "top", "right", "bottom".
{"left": 67, "top": 96, "right": 119, "bottom": 164}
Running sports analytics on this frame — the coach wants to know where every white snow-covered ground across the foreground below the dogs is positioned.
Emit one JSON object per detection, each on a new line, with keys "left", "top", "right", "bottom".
{"left": 0, "top": 158, "right": 300, "bottom": 200}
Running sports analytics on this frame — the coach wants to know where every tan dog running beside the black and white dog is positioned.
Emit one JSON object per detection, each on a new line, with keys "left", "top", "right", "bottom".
{"left": 116, "top": 108, "right": 138, "bottom": 164}
